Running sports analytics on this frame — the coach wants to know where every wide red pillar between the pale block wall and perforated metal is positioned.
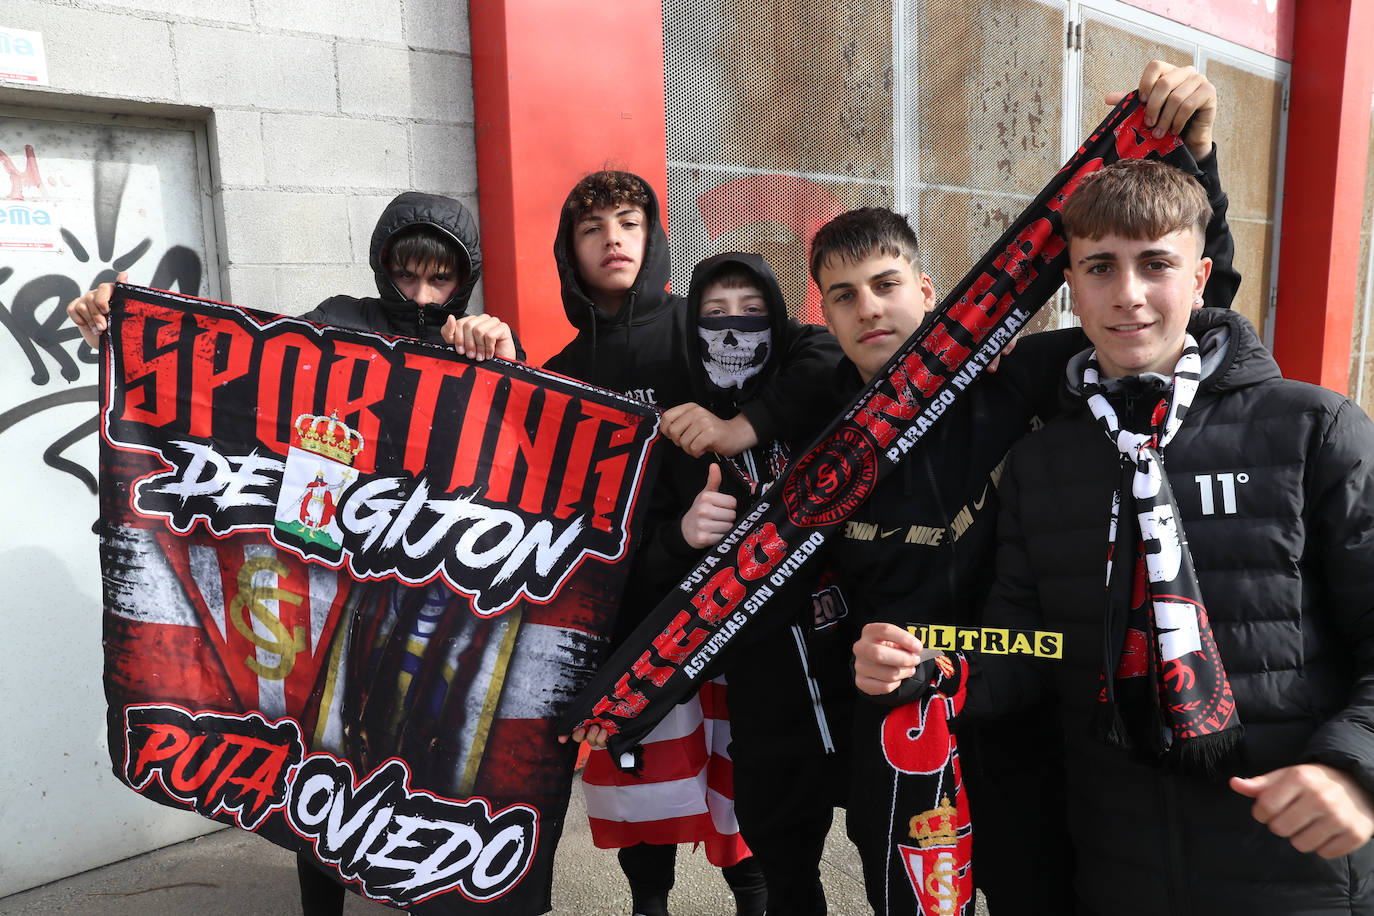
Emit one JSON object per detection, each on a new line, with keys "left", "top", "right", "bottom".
{"left": 469, "top": 0, "right": 668, "bottom": 364}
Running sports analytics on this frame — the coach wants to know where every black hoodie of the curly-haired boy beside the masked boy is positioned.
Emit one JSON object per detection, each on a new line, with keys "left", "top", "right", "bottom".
{"left": 544, "top": 184, "right": 840, "bottom": 442}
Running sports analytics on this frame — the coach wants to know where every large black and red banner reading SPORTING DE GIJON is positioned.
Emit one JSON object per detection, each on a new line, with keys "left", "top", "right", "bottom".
{"left": 100, "top": 286, "right": 658, "bottom": 913}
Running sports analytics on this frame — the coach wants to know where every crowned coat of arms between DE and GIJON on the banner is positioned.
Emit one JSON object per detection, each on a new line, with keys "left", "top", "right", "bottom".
{"left": 272, "top": 413, "right": 367, "bottom": 560}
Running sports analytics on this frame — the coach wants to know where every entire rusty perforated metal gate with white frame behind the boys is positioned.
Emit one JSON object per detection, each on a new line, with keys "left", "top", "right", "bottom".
{"left": 664, "top": 0, "right": 1287, "bottom": 340}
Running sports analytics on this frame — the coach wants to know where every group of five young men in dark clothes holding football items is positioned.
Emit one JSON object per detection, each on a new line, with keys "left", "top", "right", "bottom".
{"left": 69, "top": 62, "right": 1374, "bottom": 916}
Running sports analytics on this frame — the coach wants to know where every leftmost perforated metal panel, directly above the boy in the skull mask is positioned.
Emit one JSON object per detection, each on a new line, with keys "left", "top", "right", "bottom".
{"left": 664, "top": 0, "right": 893, "bottom": 321}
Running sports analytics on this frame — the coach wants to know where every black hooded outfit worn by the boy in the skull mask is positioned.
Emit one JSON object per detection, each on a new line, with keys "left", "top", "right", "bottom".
{"left": 617, "top": 253, "right": 853, "bottom": 916}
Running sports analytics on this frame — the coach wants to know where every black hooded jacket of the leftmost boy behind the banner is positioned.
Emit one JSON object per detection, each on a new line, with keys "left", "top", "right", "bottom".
{"left": 301, "top": 191, "right": 500, "bottom": 348}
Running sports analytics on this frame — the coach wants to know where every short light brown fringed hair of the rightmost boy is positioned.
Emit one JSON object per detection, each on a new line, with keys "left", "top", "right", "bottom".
{"left": 1063, "top": 159, "right": 1212, "bottom": 245}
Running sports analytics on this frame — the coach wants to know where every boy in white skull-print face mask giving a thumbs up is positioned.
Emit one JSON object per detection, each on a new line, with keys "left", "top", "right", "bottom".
{"left": 626, "top": 253, "right": 855, "bottom": 913}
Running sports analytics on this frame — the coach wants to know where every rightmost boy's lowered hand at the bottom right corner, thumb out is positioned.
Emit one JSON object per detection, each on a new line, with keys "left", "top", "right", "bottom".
{"left": 1231, "top": 764, "right": 1374, "bottom": 858}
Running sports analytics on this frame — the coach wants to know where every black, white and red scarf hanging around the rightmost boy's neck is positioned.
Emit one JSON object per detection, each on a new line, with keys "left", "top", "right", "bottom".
{"left": 1083, "top": 335, "right": 1243, "bottom": 777}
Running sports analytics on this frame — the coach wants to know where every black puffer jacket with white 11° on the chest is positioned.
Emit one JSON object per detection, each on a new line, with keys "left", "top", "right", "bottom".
{"left": 965, "top": 309, "right": 1374, "bottom": 916}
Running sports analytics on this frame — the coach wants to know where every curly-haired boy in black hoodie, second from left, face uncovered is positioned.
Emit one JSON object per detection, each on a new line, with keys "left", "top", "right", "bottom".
{"left": 544, "top": 172, "right": 838, "bottom": 913}
